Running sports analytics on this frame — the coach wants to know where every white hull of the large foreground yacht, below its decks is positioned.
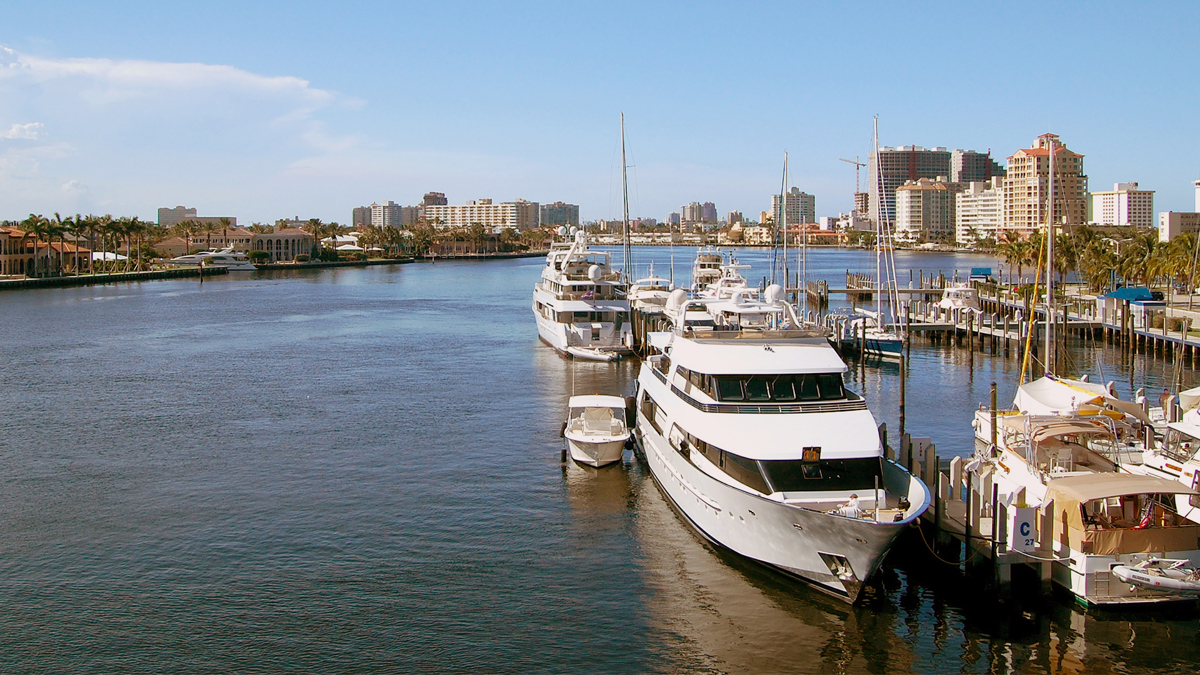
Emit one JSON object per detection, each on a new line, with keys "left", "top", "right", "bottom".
{"left": 638, "top": 411, "right": 908, "bottom": 602}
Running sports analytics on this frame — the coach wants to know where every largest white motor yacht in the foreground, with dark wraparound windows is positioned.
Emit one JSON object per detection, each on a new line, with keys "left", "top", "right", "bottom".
{"left": 636, "top": 285, "right": 930, "bottom": 602}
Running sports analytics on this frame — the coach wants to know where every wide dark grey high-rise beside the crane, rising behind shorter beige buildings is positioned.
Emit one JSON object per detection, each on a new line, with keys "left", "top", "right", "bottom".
{"left": 868, "top": 145, "right": 1004, "bottom": 222}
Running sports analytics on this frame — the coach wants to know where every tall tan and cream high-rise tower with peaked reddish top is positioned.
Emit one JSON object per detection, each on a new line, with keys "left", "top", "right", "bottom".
{"left": 1003, "top": 133, "right": 1087, "bottom": 237}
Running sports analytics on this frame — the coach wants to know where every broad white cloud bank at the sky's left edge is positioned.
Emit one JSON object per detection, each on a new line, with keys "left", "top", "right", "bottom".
{"left": 0, "top": 46, "right": 368, "bottom": 217}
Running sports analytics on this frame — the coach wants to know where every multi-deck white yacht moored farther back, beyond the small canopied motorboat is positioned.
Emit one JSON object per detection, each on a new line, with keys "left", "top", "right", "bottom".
{"left": 533, "top": 232, "right": 634, "bottom": 360}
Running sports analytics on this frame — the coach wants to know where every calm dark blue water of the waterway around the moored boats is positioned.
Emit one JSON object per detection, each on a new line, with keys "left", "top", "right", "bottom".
{"left": 0, "top": 249, "right": 1200, "bottom": 673}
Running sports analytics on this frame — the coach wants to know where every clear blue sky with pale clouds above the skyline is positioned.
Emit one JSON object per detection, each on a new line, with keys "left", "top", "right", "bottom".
{"left": 0, "top": 0, "right": 1200, "bottom": 223}
